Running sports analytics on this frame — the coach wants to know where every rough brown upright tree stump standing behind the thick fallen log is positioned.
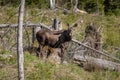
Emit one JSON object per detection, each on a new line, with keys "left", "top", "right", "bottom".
{"left": 83, "top": 24, "right": 102, "bottom": 58}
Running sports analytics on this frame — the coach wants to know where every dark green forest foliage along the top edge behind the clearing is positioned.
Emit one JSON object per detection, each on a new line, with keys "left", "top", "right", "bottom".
{"left": 0, "top": 0, "right": 120, "bottom": 16}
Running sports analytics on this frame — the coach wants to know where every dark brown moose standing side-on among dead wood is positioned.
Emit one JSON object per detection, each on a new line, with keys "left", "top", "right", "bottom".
{"left": 36, "top": 23, "right": 77, "bottom": 61}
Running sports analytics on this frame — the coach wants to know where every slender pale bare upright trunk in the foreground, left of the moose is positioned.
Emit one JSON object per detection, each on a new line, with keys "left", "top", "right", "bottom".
{"left": 17, "top": 0, "right": 25, "bottom": 80}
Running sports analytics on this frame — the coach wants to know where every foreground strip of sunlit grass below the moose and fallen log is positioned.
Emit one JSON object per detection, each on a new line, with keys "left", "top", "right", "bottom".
{"left": 0, "top": 52, "right": 120, "bottom": 80}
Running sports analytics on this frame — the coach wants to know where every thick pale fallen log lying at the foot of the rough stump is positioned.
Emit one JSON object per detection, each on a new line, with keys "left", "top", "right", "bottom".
{"left": 73, "top": 54, "right": 120, "bottom": 72}
